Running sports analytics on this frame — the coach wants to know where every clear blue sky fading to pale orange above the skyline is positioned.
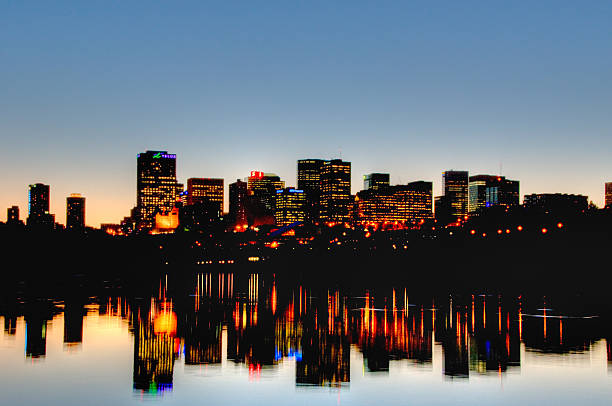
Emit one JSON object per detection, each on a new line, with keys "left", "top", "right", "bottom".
{"left": 0, "top": 0, "right": 612, "bottom": 226}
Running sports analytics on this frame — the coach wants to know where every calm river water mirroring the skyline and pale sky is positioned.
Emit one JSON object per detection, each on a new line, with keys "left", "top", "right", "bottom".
{"left": 0, "top": 273, "right": 612, "bottom": 405}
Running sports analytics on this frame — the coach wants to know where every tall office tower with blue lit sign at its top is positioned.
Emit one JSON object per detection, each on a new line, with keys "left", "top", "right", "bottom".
{"left": 135, "top": 151, "right": 183, "bottom": 230}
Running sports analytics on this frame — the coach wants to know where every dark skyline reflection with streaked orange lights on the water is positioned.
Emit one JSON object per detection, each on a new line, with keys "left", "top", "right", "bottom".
{"left": 3, "top": 273, "right": 612, "bottom": 395}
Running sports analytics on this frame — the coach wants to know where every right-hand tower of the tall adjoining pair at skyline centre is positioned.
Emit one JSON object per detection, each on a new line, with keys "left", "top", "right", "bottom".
{"left": 321, "top": 159, "right": 352, "bottom": 223}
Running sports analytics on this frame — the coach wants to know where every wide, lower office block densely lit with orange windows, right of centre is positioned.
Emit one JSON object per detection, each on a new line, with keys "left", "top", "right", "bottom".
{"left": 355, "top": 181, "right": 433, "bottom": 225}
